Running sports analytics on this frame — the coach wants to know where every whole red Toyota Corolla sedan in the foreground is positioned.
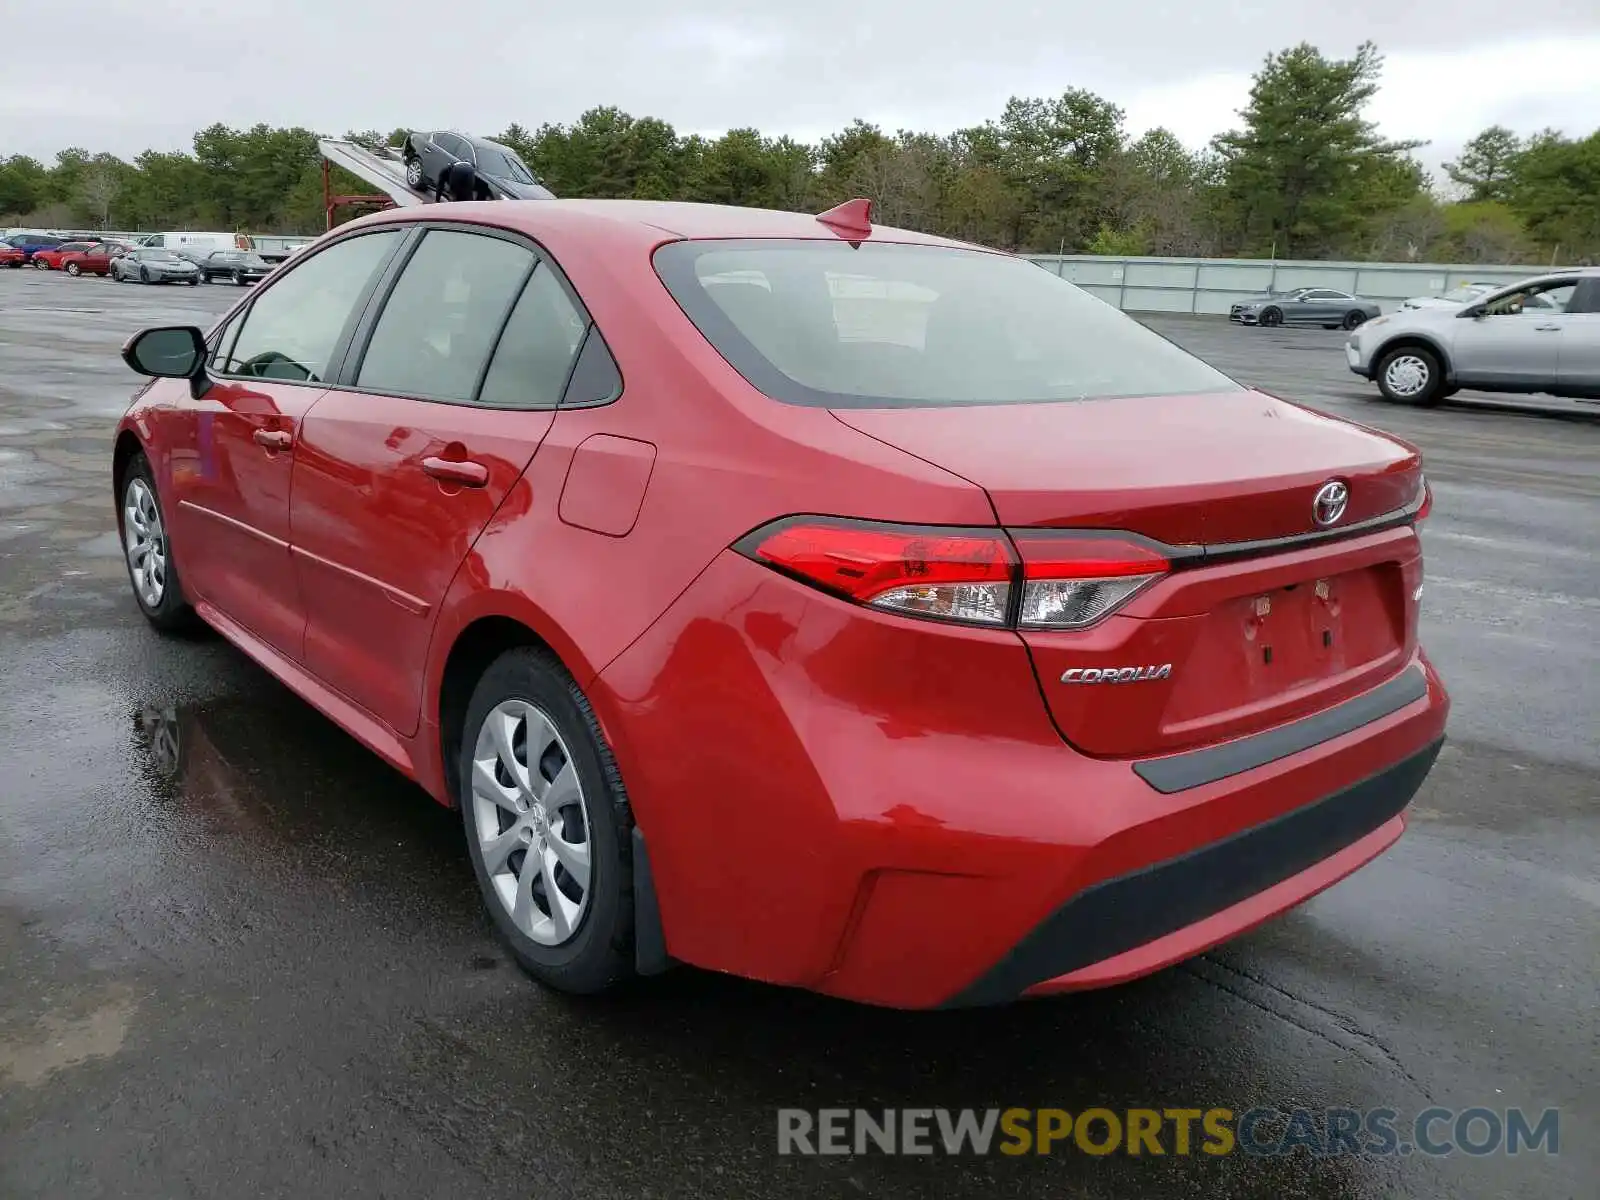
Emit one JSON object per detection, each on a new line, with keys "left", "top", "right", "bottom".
{"left": 114, "top": 200, "right": 1448, "bottom": 1008}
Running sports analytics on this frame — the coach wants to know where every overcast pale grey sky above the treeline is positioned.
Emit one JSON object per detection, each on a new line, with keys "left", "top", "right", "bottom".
{"left": 0, "top": 0, "right": 1600, "bottom": 177}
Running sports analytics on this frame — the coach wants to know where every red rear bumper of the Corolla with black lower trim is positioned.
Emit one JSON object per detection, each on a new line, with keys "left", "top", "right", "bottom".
{"left": 590, "top": 552, "right": 1450, "bottom": 1008}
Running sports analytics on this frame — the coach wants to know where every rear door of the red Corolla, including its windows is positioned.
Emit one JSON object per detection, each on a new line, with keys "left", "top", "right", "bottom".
{"left": 290, "top": 224, "right": 587, "bottom": 734}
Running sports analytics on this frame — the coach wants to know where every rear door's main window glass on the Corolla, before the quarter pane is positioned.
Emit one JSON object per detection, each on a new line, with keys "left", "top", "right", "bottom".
{"left": 355, "top": 229, "right": 534, "bottom": 403}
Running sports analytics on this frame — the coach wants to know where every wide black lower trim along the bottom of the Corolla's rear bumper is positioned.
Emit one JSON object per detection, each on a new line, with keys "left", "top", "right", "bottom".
{"left": 944, "top": 738, "right": 1445, "bottom": 1008}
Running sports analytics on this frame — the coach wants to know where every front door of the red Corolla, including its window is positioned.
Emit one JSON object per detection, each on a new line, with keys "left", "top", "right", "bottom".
{"left": 170, "top": 229, "right": 402, "bottom": 659}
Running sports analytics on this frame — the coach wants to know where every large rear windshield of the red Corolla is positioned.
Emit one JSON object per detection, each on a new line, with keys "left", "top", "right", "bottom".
{"left": 654, "top": 240, "right": 1240, "bottom": 408}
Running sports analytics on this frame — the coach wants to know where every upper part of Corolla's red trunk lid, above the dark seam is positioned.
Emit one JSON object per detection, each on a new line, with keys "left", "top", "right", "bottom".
{"left": 834, "top": 390, "right": 1421, "bottom": 544}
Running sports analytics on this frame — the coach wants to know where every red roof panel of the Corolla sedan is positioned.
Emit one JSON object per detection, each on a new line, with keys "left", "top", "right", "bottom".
{"left": 342, "top": 200, "right": 1002, "bottom": 253}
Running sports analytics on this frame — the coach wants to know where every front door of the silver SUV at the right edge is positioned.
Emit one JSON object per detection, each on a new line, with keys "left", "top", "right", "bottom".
{"left": 1450, "top": 280, "right": 1574, "bottom": 392}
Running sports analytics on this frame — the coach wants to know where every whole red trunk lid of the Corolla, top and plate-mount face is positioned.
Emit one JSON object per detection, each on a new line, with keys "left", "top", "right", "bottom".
{"left": 835, "top": 390, "right": 1421, "bottom": 757}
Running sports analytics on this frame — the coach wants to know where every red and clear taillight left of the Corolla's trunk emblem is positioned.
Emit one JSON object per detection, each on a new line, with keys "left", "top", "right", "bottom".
{"left": 736, "top": 517, "right": 1170, "bottom": 629}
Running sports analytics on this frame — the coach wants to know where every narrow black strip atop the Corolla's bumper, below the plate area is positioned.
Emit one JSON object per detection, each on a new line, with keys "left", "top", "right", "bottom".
{"left": 1133, "top": 666, "right": 1427, "bottom": 795}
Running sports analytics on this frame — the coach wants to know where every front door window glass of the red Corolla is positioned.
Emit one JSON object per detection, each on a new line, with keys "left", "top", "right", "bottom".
{"left": 222, "top": 229, "right": 400, "bottom": 382}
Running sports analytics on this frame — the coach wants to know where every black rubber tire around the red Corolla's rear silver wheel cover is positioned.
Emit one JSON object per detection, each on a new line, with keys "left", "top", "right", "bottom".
{"left": 456, "top": 646, "right": 634, "bottom": 994}
